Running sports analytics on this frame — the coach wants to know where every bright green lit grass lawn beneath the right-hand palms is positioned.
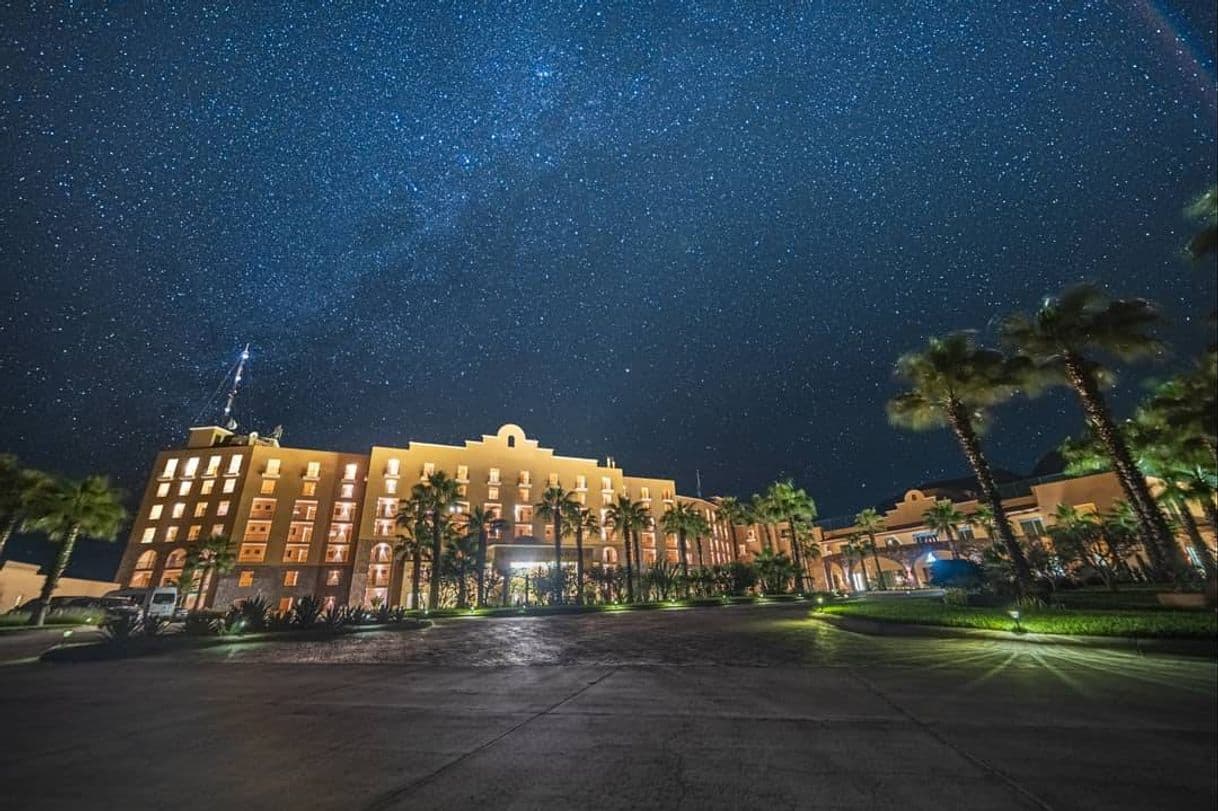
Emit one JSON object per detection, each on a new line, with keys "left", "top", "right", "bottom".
{"left": 820, "top": 599, "right": 1218, "bottom": 639}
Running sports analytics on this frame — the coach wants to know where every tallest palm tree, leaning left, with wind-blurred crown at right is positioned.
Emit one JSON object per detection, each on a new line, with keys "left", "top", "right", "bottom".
{"left": 1001, "top": 285, "right": 1174, "bottom": 570}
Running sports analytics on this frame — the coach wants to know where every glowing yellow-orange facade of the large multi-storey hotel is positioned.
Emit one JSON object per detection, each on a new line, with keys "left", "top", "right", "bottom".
{"left": 118, "top": 425, "right": 733, "bottom": 609}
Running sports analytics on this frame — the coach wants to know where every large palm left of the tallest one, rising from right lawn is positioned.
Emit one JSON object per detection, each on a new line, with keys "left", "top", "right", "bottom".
{"left": 888, "top": 332, "right": 1032, "bottom": 591}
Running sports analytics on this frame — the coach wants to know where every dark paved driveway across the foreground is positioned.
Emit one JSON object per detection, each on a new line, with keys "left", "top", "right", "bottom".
{"left": 0, "top": 605, "right": 1218, "bottom": 811}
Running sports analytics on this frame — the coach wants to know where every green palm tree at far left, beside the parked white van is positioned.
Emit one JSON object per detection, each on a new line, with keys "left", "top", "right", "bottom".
{"left": 22, "top": 476, "right": 127, "bottom": 625}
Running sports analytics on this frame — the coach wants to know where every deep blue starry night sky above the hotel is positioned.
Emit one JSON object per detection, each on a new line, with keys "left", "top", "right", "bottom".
{"left": 0, "top": 0, "right": 1216, "bottom": 574}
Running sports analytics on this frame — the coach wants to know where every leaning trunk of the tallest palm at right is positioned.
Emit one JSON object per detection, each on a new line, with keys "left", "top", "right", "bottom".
{"left": 1062, "top": 353, "right": 1179, "bottom": 576}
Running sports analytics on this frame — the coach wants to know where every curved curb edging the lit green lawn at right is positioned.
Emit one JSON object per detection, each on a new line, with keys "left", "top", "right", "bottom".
{"left": 812, "top": 613, "right": 1218, "bottom": 659}
